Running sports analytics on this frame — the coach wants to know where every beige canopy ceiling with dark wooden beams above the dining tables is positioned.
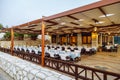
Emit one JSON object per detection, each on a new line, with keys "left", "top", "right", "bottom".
{"left": 3, "top": 0, "right": 120, "bottom": 34}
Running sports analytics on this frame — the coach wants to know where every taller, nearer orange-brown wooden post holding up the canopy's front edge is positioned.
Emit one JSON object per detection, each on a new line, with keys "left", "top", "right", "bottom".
{"left": 41, "top": 21, "right": 45, "bottom": 67}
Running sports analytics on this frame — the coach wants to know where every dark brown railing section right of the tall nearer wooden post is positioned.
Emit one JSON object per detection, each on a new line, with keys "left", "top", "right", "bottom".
{"left": 45, "top": 58, "right": 120, "bottom": 80}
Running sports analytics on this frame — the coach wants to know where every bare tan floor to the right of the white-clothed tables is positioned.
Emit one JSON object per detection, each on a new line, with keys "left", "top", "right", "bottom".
{"left": 77, "top": 51, "right": 120, "bottom": 74}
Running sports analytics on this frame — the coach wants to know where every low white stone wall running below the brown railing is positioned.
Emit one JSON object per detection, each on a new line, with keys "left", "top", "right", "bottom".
{"left": 0, "top": 52, "right": 75, "bottom": 80}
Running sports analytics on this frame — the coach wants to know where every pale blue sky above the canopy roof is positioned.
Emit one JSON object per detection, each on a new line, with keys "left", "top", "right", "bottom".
{"left": 0, "top": 0, "right": 100, "bottom": 27}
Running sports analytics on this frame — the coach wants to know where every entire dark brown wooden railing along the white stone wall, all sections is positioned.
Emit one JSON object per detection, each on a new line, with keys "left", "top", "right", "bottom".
{"left": 0, "top": 48, "right": 120, "bottom": 80}
